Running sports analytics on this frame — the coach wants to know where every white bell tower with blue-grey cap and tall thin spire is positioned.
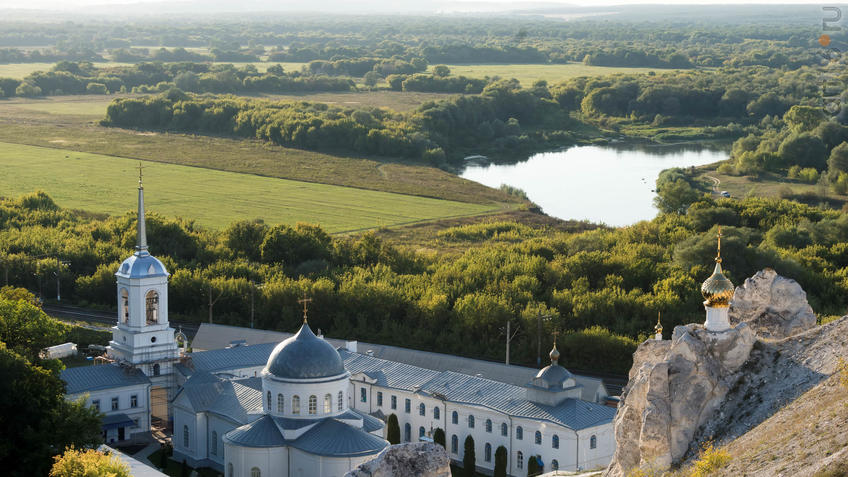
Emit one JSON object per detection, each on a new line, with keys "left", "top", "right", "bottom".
{"left": 107, "top": 166, "right": 179, "bottom": 378}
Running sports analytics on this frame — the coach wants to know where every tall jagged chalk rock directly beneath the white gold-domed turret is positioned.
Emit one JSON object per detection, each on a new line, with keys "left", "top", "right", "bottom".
{"left": 605, "top": 323, "right": 756, "bottom": 477}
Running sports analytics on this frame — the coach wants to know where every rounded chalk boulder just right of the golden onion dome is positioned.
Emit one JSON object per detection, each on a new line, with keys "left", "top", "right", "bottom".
{"left": 730, "top": 268, "right": 816, "bottom": 339}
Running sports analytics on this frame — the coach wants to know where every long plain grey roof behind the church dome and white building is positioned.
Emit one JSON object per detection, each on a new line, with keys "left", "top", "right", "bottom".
{"left": 187, "top": 323, "right": 626, "bottom": 400}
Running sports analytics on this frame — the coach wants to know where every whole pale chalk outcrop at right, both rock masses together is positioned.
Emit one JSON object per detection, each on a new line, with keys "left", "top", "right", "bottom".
{"left": 604, "top": 269, "right": 820, "bottom": 477}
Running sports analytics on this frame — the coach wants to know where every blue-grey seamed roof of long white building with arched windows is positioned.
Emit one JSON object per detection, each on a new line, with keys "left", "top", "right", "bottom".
{"left": 339, "top": 350, "right": 616, "bottom": 430}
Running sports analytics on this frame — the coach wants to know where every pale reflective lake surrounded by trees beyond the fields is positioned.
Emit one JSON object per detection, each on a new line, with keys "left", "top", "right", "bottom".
{"left": 460, "top": 145, "right": 728, "bottom": 226}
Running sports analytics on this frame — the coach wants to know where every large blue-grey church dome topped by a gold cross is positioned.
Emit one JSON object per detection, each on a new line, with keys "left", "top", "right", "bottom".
{"left": 265, "top": 323, "right": 345, "bottom": 379}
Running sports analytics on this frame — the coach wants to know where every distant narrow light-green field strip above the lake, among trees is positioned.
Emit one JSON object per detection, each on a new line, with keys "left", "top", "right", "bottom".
{"left": 430, "top": 63, "right": 674, "bottom": 86}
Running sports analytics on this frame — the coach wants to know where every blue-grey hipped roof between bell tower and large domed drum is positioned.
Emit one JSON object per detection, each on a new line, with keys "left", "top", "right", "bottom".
{"left": 174, "top": 371, "right": 262, "bottom": 423}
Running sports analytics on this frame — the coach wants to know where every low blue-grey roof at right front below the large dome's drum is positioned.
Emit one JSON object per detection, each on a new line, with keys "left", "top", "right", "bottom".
{"left": 291, "top": 419, "right": 389, "bottom": 457}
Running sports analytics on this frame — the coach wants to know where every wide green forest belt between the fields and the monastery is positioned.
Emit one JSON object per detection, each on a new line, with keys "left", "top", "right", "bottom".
{"left": 0, "top": 193, "right": 848, "bottom": 373}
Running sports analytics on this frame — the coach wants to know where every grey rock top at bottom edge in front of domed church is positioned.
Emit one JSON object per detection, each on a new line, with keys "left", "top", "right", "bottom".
{"left": 345, "top": 442, "right": 451, "bottom": 477}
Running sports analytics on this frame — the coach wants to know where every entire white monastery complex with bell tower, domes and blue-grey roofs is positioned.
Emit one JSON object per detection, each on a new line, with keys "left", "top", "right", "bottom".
{"left": 62, "top": 181, "right": 615, "bottom": 477}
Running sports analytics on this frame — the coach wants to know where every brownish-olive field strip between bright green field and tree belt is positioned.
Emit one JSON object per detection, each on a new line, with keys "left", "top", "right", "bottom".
{"left": 0, "top": 93, "right": 514, "bottom": 205}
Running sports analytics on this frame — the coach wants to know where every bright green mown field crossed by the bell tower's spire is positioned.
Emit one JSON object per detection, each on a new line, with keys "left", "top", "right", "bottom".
{"left": 0, "top": 143, "right": 498, "bottom": 233}
